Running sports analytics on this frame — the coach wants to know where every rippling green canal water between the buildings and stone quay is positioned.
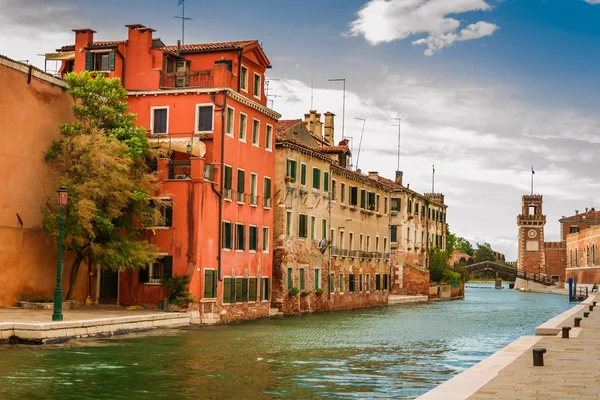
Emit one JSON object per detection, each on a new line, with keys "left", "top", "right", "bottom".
{"left": 0, "top": 284, "right": 570, "bottom": 399}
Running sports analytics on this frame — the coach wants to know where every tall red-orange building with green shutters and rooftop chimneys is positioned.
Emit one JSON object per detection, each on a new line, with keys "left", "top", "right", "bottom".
{"left": 58, "top": 25, "right": 280, "bottom": 322}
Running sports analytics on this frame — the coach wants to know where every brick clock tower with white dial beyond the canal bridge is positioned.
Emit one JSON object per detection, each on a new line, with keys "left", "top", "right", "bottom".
{"left": 517, "top": 195, "right": 546, "bottom": 274}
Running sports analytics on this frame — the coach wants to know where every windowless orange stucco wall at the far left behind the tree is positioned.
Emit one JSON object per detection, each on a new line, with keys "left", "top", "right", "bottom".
{"left": 0, "top": 58, "right": 87, "bottom": 307}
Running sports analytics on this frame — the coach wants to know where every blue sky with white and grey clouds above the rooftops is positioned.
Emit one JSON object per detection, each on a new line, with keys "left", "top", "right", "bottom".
{"left": 0, "top": 0, "right": 600, "bottom": 260}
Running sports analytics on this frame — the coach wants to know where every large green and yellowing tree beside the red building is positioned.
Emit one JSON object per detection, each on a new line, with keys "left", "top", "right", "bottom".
{"left": 42, "top": 72, "right": 161, "bottom": 299}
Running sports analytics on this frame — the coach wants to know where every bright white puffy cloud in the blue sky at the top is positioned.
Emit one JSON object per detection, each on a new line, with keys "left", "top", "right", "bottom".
{"left": 348, "top": 0, "right": 500, "bottom": 55}
